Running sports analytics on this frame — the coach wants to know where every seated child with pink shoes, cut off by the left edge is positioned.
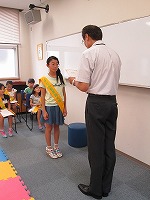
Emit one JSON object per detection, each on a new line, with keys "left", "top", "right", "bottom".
{"left": 0, "top": 83, "right": 13, "bottom": 138}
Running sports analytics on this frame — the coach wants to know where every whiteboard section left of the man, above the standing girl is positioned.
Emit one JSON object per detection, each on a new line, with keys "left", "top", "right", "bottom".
{"left": 46, "top": 33, "right": 86, "bottom": 77}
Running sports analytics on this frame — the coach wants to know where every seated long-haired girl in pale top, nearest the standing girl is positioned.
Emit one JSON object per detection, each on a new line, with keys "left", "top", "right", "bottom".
{"left": 30, "top": 84, "right": 43, "bottom": 130}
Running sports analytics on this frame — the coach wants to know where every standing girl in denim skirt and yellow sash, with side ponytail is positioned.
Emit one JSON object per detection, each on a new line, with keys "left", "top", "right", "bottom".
{"left": 40, "top": 56, "right": 67, "bottom": 158}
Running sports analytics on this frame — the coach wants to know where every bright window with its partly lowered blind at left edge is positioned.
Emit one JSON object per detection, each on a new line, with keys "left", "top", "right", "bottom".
{"left": 0, "top": 7, "right": 20, "bottom": 80}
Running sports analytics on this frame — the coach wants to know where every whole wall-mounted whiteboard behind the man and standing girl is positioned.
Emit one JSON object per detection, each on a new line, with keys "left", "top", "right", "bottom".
{"left": 47, "top": 17, "right": 150, "bottom": 87}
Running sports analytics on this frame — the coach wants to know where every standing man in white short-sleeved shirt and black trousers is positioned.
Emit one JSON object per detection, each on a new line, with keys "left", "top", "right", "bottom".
{"left": 69, "top": 25, "right": 121, "bottom": 199}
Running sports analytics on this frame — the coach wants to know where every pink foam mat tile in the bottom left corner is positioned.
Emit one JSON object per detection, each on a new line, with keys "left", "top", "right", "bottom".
{"left": 0, "top": 176, "right": 31, "bottom": 200}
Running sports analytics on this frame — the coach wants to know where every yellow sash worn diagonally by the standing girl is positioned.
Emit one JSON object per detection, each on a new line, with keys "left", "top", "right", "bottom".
{"left": 39, "top": 77, "right": 64, "bottom": 113}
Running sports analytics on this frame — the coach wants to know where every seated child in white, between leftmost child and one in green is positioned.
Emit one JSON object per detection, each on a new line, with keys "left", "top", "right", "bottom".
{"left": 4, "top": 81, "right": 18, "bottom": 113}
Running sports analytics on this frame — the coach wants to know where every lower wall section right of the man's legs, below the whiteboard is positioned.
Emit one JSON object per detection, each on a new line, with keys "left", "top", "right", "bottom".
{"left": 116, "top": 86, "right": 150, "bottom": 165}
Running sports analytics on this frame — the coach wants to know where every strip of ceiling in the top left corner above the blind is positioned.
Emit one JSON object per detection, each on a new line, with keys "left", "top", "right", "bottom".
{"left": 0, "top": 0, "right": 45, "bottom": 11}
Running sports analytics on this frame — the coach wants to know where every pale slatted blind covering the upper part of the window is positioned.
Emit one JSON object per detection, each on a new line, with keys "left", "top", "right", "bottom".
{"left": 0, "top": 7, "right": 20, "bottom": 44}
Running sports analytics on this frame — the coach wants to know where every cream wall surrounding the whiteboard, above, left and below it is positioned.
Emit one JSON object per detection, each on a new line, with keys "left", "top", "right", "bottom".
{"left": 19, "top": 0, "right": 150, "bottom": 165}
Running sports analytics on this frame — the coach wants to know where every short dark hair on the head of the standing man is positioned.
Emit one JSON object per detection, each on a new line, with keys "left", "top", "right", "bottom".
{"left": 82, "top": 25, "right": 103, "bottom": 40}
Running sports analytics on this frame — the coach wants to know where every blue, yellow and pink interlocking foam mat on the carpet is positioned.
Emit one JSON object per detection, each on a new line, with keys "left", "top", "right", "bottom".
{"left": 0, "top": 148, "right": 35, "bottom": 200}
